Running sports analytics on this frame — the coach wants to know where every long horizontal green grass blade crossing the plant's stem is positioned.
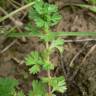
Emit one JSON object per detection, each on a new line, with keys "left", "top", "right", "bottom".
{"left": 4, "top": 32, "right": 96, "bottom": 37}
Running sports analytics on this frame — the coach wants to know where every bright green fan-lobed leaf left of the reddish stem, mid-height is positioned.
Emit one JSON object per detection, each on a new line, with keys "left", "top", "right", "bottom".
{"left": 25, "top": 51, "right": 44, "bottom": 74}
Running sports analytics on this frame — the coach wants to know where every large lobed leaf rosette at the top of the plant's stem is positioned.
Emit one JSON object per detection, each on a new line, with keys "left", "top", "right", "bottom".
{"left": 28, "top": 0, "right": 61, "bottom": 29}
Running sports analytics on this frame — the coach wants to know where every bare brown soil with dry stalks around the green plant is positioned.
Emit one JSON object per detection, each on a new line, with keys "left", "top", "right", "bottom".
{"left": 0, "top": 0, "right": 96, "bottom": 96}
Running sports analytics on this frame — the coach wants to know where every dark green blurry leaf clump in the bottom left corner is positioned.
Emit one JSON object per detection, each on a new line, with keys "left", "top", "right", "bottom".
{"left": 0, "top": 78, "right": 18, "bottom": 96}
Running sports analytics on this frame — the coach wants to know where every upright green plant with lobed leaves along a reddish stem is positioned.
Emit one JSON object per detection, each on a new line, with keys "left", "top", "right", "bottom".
{"left": 25, "top": 0, "right": 66, "bottom": 96}
